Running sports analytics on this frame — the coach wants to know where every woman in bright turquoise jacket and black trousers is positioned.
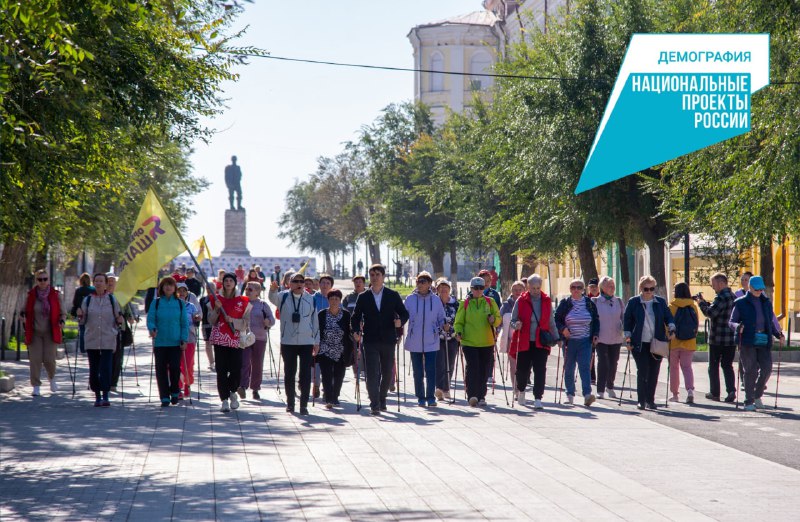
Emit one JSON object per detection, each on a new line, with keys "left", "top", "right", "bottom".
{"left": 147, "top": 277, "right": 189, "bottom": 407}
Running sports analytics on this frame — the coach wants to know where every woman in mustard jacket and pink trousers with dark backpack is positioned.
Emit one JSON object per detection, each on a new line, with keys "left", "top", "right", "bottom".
{"left": 669, "top": 283, "right": 700, "bottom": 404}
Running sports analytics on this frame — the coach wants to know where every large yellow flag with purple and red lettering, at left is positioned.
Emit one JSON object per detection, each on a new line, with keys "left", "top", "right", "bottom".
{"left": 114, "top": 188, "right": 186, "bottom": 306}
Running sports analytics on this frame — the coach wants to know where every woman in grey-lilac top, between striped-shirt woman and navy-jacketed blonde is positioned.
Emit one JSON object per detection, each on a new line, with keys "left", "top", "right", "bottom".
{"left": 592, "top": 276, "right": 625, "bottom": 399}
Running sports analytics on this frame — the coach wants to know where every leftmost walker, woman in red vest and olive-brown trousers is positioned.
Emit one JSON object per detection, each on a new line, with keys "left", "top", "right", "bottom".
{"left": 25, "top": 270, "right": 66, "bottom": 396}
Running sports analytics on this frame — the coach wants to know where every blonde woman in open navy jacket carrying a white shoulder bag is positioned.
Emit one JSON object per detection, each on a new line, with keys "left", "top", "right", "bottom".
{"left": 623, "top": 275, "right": 675, "bottom": 410}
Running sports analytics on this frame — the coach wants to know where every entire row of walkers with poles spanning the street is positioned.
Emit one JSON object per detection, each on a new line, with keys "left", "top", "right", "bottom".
{"left": 24, "top": 264, "right": 784, "bottom": 415}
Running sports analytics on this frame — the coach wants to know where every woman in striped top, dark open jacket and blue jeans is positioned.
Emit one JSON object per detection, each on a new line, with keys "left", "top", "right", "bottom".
{"left": 556, "top": 279, "right": 600, "bottom": 407}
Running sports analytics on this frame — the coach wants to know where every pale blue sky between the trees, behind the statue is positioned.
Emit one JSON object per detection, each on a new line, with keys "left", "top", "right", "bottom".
{"left": 186, "top": 0, "right": 483, "bottom": 263}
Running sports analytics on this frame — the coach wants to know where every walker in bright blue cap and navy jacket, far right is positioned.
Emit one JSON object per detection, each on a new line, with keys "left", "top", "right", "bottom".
{"left": 729, "top": 276, "right": 784, "bottom": 411}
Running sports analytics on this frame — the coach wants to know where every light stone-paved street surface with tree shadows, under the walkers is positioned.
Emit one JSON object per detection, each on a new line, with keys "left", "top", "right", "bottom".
{"left": 0, "top": 322, "right": 800, "bottom": 522}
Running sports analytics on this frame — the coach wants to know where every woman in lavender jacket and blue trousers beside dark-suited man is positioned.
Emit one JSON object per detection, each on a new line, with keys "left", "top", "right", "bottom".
{"left": 404, "top": 271, "right": 444, "bottom": 407}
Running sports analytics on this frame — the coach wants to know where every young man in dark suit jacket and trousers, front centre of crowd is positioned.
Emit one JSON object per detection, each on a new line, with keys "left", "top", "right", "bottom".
{"left": 351, "top": 264, "right": 408, "bottom": 415}
